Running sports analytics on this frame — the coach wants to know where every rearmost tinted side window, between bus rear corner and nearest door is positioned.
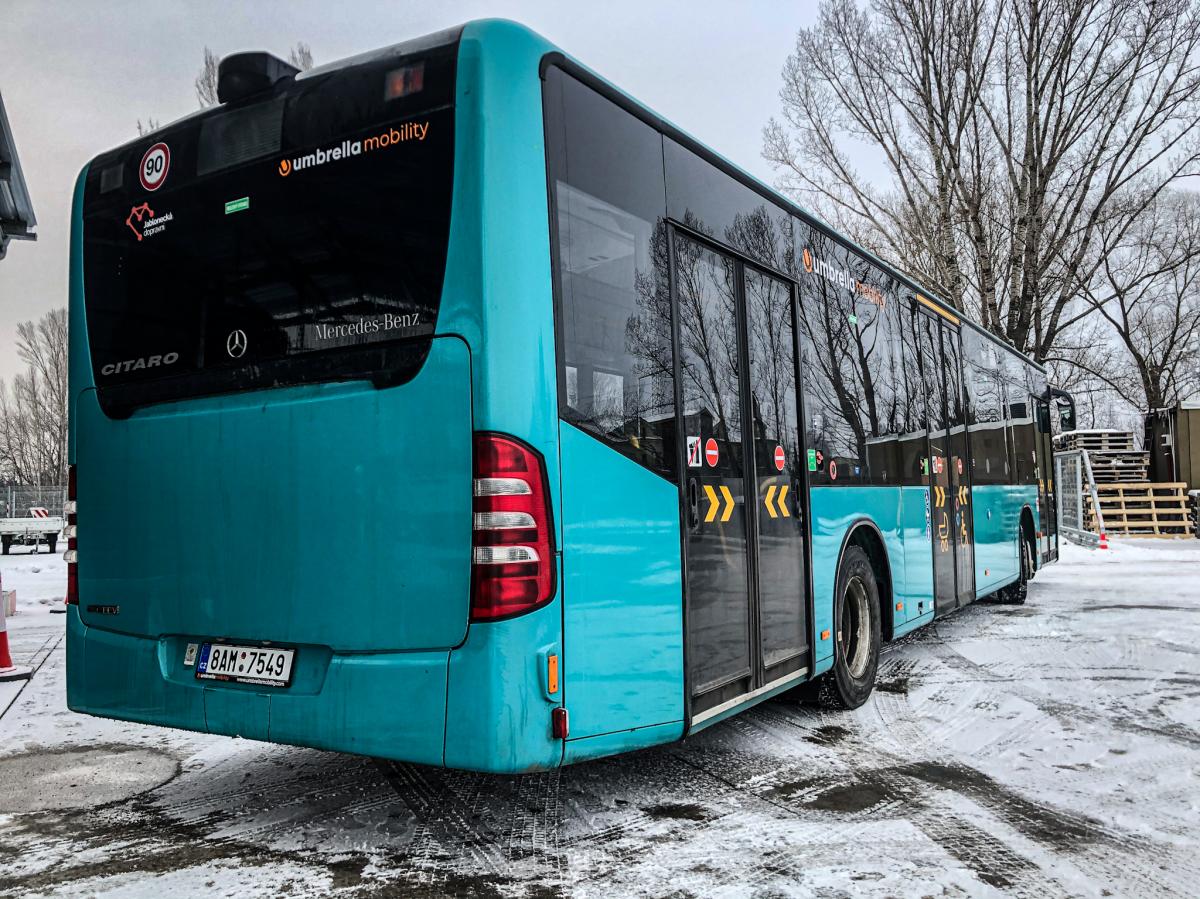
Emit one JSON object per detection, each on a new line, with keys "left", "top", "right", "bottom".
{"left": 545, "top": 68, "right": 678, "bottom": 478}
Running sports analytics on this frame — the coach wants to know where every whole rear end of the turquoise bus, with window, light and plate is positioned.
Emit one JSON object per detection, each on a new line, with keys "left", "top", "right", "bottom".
{"left": 67, "top": 24, "right": 565, "bottom": 771}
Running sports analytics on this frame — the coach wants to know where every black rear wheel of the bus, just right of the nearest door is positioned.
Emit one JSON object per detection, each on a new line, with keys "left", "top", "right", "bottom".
{"left": 806, "top": 546, "right": 882, "bottom": 709}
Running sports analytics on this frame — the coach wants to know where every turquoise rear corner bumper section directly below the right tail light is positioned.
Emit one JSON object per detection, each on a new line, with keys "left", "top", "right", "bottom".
{"left": 445, "top": 595, "right": 563, "bottom": 774}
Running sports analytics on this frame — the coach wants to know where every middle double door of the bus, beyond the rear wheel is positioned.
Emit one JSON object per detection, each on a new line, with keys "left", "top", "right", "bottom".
{"left": 913, "top": 308, "right": 974, "bottom": 615}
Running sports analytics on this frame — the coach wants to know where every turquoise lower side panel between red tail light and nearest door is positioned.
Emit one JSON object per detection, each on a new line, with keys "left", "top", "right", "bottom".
{"left": 559, "top": 424, "right": 684, "bottom": 751}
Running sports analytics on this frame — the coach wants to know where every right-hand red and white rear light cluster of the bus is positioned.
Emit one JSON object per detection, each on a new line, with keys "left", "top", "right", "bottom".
{"left": 470, "top": 433, "right": 554, "bottom": 622}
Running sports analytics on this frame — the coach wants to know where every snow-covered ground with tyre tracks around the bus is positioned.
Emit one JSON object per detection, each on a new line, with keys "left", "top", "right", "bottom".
{"left": 0, "top": 540, "right": 1200, "bottom": 899}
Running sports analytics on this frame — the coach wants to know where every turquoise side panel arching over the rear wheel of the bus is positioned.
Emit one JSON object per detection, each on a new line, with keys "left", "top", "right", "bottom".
{"left": 809, "top": 486, "right": 905, "bottom": 673}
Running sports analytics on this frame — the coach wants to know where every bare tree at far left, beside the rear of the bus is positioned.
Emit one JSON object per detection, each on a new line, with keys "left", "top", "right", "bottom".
{"left": 0, "top": 308, "right": 68, "bottom": 485}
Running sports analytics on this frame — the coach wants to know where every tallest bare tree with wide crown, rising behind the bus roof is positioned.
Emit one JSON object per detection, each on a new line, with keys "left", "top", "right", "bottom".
{"left": 763, "top": 0, "right": 1200, "bottom": 359}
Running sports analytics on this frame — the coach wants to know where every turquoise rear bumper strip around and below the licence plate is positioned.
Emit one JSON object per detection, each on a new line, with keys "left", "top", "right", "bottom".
{"left": 66, "top": 606, "right": 449, "bottom": 765}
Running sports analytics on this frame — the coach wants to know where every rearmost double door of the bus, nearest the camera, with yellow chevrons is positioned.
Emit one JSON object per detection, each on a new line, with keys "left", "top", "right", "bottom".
{"left": 672, "top": 230, "right": 810, "bottom": 719}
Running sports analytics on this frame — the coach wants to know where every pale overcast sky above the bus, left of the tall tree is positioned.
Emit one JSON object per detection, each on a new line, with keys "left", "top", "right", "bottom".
{"left": 0, "top": 0, "right": 816, "bottom": 378}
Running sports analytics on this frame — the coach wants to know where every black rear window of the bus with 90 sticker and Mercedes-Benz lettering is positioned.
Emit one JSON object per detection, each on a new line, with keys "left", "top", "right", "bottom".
{"left": 77, "top": 35, "right": 456, "bottom": 414}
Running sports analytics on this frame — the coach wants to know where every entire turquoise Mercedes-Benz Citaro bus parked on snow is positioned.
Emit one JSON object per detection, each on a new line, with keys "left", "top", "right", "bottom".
{"left": 67, "top": 20, "right": 1072, "bottom": 772}
